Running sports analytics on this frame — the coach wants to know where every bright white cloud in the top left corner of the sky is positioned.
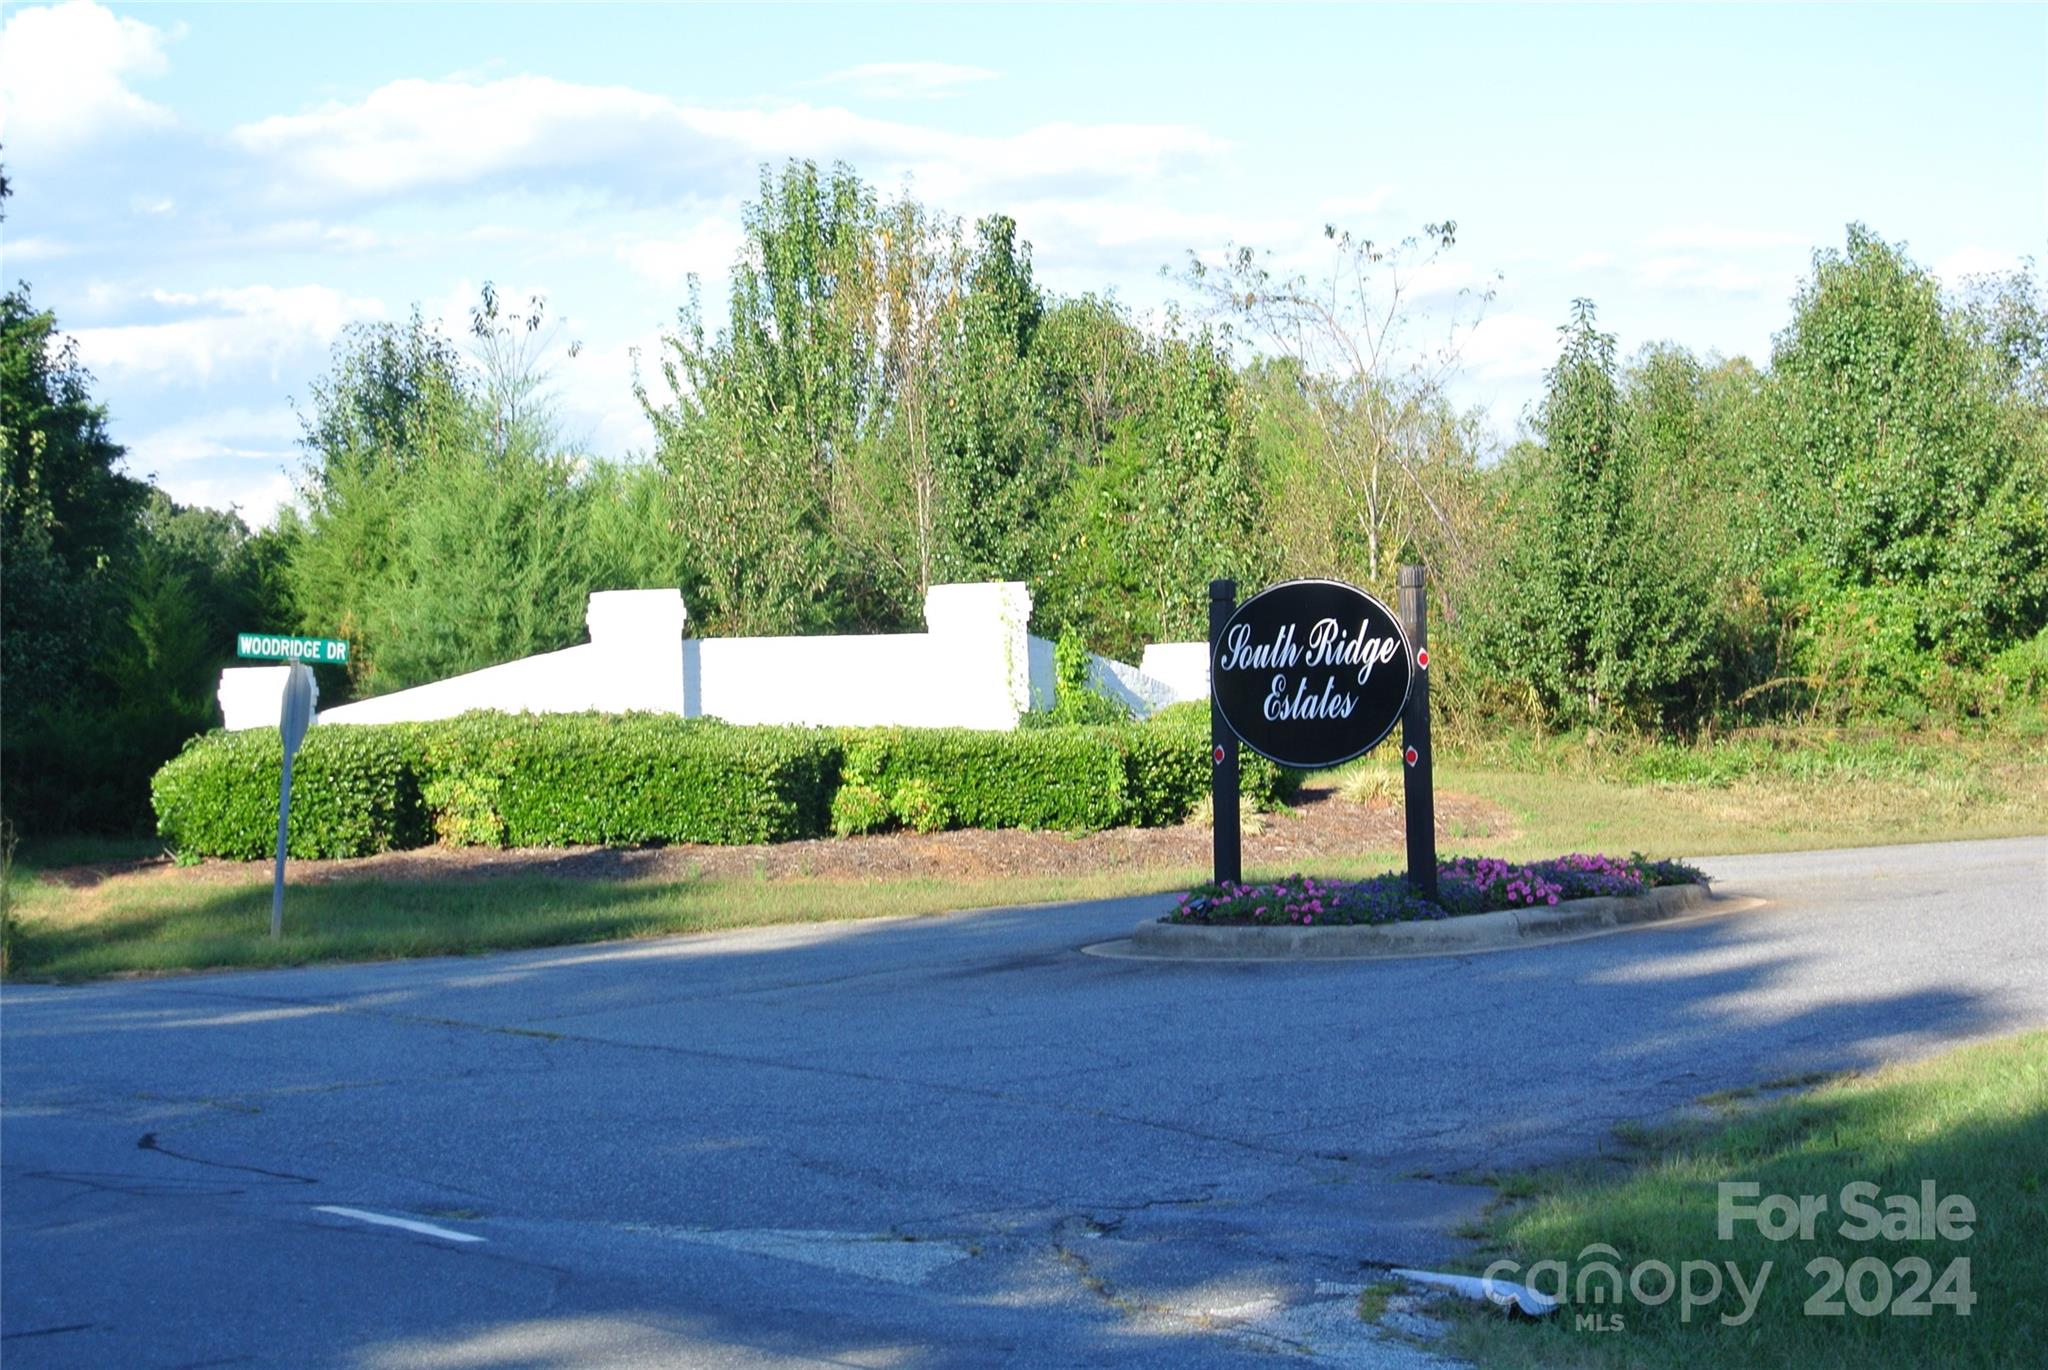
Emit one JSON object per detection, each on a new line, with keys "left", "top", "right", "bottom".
{"left": 0, "top": 0, "right": 174, "bottom": 160}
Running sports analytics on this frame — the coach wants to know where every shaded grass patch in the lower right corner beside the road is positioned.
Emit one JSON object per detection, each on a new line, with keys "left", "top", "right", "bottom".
{"left": 1452, "top": 1032, "right": 2048, "bottom": 1370}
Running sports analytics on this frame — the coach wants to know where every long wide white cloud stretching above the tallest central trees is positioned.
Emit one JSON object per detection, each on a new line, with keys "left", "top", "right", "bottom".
{"left": 231, "top": 76, "right": 1225, "bottom": 199}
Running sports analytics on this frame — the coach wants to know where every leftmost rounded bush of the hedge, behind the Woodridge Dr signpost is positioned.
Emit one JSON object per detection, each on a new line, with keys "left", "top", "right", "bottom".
{"left": 150, "top": 723, "right": 428, "bottom": 860}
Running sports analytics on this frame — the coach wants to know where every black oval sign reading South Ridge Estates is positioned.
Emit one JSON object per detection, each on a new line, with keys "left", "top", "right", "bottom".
{"left": 1208, "top": 580, "right": 1415, "bottom": 770}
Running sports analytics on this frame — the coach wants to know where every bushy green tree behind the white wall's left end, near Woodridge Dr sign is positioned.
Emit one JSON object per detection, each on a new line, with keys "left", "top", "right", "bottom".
{"left": 285, "top": 295, "right": 604, "bottom": 694}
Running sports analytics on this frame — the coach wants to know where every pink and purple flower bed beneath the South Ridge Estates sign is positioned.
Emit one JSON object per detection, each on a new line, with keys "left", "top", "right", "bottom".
{"left": 1159, "top": 852, "right": 1706, "bottom": 926}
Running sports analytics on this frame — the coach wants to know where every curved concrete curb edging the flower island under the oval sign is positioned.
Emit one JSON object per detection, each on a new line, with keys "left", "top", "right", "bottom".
{"left": 1130, "top": 885, "right": 1714, "bottom": 960}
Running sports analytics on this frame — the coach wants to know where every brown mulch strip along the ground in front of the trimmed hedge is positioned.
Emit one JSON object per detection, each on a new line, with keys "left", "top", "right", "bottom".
{"left": 43, "top": 786, "right": 1513, "bottom": 889}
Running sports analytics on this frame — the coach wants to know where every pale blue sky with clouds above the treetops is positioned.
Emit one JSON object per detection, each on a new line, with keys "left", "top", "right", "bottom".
{"left": 0, "top": 0, "right": 2048, "bottom": 522}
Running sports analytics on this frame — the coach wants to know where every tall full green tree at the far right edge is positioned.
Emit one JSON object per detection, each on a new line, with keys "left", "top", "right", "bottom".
{"left": 1769, "top": 225, "right": 2048, "bottom": 707}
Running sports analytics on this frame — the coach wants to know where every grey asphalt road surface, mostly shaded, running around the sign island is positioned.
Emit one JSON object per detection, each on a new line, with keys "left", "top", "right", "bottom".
{"left": 12, "top": 838, "right": 2048, "bottom": 1370}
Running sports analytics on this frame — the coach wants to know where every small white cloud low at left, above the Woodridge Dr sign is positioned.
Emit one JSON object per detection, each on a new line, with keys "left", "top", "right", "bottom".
{"left": 76, "top": 285, "right": 385, "bottom": 383}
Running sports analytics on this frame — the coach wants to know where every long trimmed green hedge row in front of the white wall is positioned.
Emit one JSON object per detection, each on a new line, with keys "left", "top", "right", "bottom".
{"left": 152, "top": 704, "right": 1294, "bottom": 860}
